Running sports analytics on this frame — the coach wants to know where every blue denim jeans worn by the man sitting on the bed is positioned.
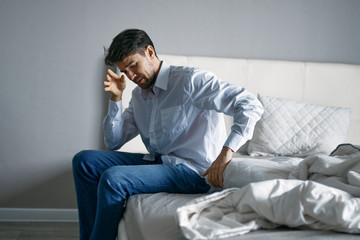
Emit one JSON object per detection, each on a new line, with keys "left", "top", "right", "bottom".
{"left": 73, "top": 150, "right": 210, "bottom": 240}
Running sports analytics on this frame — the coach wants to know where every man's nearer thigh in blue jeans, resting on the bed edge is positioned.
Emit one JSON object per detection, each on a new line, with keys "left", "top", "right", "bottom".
{"left": 100, "top": 164, "right": 209, "bottom": 196}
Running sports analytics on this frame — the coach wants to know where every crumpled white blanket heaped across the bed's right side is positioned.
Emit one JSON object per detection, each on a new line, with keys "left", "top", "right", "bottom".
{"left": 177, "top": 147, "right": 360, "bottom": 239}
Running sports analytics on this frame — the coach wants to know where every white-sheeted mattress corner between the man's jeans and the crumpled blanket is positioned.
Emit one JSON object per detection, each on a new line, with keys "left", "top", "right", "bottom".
{"left": 118, "top": 193, "right": 204, "bottom": 240}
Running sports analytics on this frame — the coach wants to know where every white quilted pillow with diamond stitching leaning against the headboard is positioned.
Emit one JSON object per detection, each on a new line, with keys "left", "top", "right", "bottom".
{"left": 248, "top": 95, "right": 351, "bottom": 157}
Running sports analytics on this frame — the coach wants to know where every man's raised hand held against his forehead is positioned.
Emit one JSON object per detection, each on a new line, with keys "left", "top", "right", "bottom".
{"left": 104, "top": 69, "right": 126, "bottom": 102}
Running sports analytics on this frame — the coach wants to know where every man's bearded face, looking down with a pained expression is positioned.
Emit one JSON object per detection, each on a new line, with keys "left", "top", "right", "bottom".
{"left": 115, "top": 51, "right": 156, "bottom": 89}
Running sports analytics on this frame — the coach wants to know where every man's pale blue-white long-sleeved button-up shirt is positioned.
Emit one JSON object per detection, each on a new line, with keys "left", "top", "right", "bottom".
{"left": 103, "top": 62, "right": 263, "bottom": 175}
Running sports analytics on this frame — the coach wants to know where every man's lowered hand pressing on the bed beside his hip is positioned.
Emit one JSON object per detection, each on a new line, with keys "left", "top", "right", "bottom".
{"left": 203, "top": 147, "right": 234, "bottom": 187}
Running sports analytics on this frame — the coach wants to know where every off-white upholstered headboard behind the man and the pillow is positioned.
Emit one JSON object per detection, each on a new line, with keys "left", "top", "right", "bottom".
{"left": 122, "top": 55, "right": 360, "bottom": 152}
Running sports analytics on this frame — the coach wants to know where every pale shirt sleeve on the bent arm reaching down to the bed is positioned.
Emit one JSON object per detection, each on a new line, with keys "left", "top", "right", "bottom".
{"left": 188, "top": 71, "right": 263, "bottom": 151}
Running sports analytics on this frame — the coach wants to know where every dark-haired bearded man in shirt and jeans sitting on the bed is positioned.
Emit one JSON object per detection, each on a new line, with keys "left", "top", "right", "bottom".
{"left": 73, "top": 29, "right": 263, "bottom": 240}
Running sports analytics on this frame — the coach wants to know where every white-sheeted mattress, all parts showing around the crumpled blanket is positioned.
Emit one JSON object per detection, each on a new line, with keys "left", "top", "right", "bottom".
{"left": 118, "top": 152, "right": 359, "bottom": 240}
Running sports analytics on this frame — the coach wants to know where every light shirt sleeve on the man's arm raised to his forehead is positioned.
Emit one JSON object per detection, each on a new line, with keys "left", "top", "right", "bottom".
{"left": 103, "top": 100, "right": 139, "bottom": 150}
